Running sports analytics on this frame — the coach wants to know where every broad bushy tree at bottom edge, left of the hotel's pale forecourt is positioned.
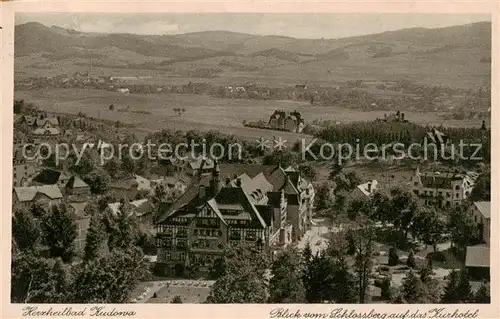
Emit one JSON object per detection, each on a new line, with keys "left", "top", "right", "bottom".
{"left": 70, "top": 247, "right": 149, "bottom": 303}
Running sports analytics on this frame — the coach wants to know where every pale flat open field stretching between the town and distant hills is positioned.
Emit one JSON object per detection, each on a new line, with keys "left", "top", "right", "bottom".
{"left": 15, "top": 89, "right": 481, "bottom": 142}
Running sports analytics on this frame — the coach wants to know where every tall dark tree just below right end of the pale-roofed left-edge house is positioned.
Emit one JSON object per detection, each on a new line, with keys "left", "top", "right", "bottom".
{"left": 40, "top": 204, "right": 77, "bottom": 262}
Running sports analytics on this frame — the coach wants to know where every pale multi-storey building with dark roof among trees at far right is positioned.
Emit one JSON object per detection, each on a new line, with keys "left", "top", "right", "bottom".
{"left": 411, "top": 167, "right": 474, "bottom": 207}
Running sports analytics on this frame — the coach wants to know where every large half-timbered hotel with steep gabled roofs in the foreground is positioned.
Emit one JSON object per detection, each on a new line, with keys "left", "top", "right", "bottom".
{"left": 157, "top": 162, "right": 314, "bottom": 274}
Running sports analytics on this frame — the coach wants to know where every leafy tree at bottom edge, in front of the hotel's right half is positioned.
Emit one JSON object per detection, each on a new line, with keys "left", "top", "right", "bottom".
{"left": 207, "top": 245, "right": 269, "bottom": 303}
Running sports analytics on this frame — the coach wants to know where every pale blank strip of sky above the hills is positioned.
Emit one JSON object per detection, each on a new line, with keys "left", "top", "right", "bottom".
{"left": 16, "top": 13, "right": 491, "bottom": 39}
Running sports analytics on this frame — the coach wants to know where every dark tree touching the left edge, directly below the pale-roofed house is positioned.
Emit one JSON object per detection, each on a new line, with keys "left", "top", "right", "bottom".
{"left": 12, "top": 209, "right": 40, "bottom": 250}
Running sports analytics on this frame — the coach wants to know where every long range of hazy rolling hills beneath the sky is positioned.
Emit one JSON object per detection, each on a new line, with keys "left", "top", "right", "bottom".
{"left": 15, "top": 22, "right": 491, "bottom": 87}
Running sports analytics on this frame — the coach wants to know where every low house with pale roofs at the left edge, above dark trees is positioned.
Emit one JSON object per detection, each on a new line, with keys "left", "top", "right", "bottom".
{"left": 12, "top": 185, "right": 63, "bottom": 208}
